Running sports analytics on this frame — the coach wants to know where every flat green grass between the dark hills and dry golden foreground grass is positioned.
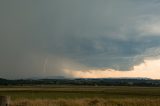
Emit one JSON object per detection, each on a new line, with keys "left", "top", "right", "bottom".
{"left": 0, "top": 86, "right": 160, "bottom": 100}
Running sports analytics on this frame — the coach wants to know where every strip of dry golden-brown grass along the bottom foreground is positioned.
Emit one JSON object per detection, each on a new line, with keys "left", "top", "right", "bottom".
{"left": 11, "top": 98, "right": 160, "bottom": 106}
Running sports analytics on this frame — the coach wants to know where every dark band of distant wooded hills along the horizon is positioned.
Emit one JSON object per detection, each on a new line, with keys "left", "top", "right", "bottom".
{"left": 0, "top": 76, "right": 160, "bottom": 87}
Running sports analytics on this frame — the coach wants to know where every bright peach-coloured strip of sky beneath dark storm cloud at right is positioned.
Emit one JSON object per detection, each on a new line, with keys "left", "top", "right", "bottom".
{"left": 64, "top": 59, "right": 160, "bottom": 79}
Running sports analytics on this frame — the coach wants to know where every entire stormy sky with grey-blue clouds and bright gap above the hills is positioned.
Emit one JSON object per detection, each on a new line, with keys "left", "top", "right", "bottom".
{"left": 0, "top": 0, "right": 160, "bottom": 79}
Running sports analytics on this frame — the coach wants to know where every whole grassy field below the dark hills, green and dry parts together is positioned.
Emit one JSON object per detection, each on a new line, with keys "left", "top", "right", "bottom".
{"left": 0, "top": 86, "right": 160, "bottom": 106}
